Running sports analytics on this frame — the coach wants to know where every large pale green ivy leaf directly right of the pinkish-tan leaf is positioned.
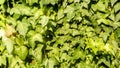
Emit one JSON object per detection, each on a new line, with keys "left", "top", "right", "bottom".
{"left": 17, "top": 21, "right": 29, "bottom": 36}
